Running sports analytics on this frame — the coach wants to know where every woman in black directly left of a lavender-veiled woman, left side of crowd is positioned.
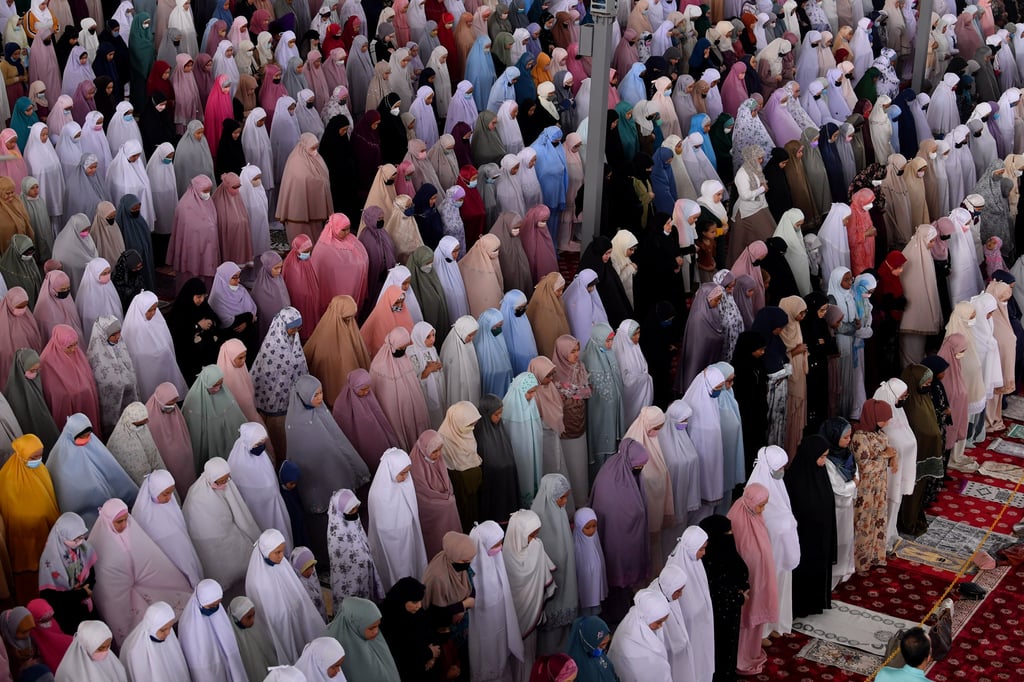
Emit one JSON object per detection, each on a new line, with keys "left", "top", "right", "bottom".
{"left": 167, "top": 278, "right": 223, "bottom": 386}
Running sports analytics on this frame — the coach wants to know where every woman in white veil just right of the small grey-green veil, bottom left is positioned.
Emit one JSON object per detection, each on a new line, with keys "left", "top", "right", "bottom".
{"left": 246, "top": 524, "right": 323, "bottom": 664}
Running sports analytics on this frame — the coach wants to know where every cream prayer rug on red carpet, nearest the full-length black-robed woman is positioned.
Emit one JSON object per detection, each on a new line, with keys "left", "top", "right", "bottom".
{"left": 793, "top": 600, "right": 918, "bottom": 656}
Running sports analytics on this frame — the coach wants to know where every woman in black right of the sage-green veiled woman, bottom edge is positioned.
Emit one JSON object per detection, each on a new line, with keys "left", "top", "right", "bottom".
{"left": 381, "top": 577, "right": 434, "bottom": 680}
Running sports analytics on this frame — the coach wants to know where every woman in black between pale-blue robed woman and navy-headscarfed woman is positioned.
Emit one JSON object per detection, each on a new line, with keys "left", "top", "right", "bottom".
{"left": 737, "top": 332, "right": 768, "bottom": 476}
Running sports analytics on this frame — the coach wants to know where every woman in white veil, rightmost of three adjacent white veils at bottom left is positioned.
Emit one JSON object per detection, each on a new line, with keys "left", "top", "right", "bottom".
{"left": 178, "top": 580, "right": 249, "bottom": 682}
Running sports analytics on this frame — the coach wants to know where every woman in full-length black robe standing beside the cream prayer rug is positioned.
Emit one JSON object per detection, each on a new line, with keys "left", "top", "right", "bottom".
{"left": 784, "top": 434, "right": 838, "bottom": 619}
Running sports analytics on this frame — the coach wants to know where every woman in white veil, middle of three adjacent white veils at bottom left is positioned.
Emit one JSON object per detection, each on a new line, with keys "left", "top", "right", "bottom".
{"left": 121, "top": 601, "right": 189, "bottom": 682}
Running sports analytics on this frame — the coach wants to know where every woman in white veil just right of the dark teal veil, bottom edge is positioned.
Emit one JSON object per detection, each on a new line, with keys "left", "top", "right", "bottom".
{"left": 608, "top": 589, "right": 673, "bottom": 682}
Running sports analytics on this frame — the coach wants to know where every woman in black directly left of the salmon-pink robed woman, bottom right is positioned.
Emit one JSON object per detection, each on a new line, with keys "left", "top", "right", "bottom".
{"left": 699, "top": 514, "right": 751, "bottom": 680}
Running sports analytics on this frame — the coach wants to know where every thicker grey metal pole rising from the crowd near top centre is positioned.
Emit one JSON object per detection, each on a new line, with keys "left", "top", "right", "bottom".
{"left": 580, "top": 12, "right": 615, "bottom": 248}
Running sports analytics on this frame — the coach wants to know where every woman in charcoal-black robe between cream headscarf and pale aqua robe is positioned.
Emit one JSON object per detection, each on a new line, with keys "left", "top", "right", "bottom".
{"left": 473, "top": 391, "right": 520, "bottom": 527}
